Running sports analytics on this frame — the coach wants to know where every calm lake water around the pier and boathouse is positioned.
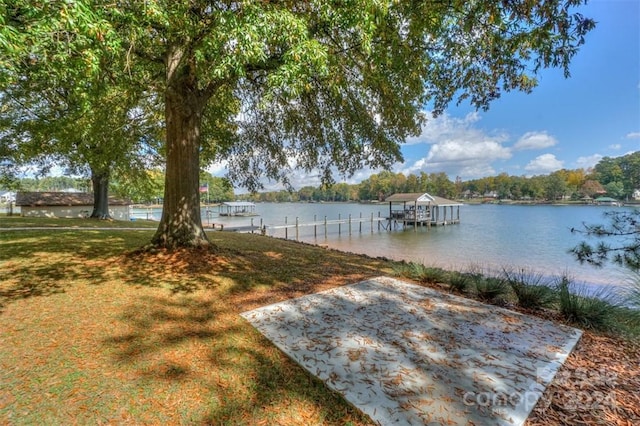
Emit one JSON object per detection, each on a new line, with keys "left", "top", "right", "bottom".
{"left": 136, "top": 203, "right": 628, "bottom": 292}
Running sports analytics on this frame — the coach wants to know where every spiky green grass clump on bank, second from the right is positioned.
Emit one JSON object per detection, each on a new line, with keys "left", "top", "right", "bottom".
{"left": 502, "top": 268, "right": 558, "bottom": 309}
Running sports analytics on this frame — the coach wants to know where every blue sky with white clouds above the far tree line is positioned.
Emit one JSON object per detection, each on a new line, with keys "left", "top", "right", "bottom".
{"left": 239, "top": 0, "right": 640, "bottom": 189}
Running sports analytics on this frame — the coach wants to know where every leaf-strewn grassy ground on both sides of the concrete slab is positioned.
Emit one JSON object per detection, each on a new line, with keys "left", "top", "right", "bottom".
{"left": 0, "top": 217, "right": 640, "bottom": 425}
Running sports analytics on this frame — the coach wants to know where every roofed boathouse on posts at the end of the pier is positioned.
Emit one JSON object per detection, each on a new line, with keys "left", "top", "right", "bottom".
{"left": 385, "top": 192, "right": 463, "bottom": 227}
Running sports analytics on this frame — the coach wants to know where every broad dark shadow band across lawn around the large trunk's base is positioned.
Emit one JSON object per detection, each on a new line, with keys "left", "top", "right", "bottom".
{"left": 0, "top": 226, "right": 385, "bottom": 316}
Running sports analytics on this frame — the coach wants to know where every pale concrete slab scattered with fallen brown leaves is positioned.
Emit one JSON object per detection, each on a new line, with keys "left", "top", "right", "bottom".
{"left": 242, "top": 277, "right": 581, "bottom": 425}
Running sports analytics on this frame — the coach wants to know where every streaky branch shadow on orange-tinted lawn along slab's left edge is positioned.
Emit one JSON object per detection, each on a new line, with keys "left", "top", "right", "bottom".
{"left": 102, "top": 295, "right": 368, "bottom": 424}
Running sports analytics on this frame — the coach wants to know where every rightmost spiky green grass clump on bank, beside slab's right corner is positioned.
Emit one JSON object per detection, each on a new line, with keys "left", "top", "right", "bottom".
{"left": 557, "top": 275, "right": 620, "bottom": 331}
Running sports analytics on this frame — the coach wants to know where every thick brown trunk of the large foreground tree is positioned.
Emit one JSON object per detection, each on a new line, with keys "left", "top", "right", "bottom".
{"left": 151, "top": 72, "right": 209, "bottom": 248}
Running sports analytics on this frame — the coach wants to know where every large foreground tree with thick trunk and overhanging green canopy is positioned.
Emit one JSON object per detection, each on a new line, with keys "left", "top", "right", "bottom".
{"left": 0, "top": 0, "right": 593, "bottom": 247}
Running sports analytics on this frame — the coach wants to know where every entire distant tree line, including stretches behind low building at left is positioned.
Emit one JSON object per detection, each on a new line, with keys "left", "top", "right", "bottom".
{"left": 8, "top": 151, "right": 640, "bottom": 203}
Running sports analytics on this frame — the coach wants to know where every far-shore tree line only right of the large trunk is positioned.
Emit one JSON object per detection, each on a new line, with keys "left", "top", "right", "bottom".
{"left": 241, "top": 151, "right": 640, "bottom": 201}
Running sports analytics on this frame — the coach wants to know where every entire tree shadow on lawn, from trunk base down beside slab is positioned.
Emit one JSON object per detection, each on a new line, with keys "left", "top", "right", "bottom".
{"left": 0, "top": 230, "right": 385, "bottom": 424}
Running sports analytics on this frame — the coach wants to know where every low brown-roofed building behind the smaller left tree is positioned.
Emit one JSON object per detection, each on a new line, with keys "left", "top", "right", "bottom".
{"left": 16, "top": 192, "right": 131, "bottom": 220}
